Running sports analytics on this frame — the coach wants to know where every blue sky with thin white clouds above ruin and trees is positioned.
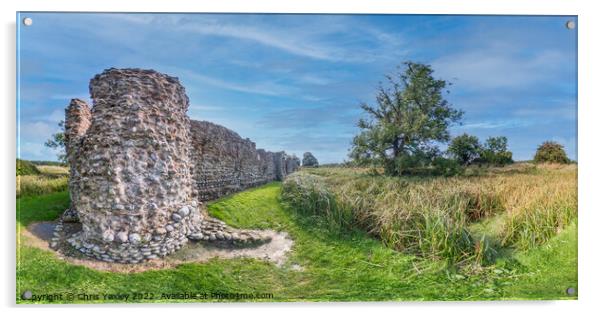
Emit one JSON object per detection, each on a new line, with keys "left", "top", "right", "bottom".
{"left": 18, "top": 13, "right": 577, "bottom": 163}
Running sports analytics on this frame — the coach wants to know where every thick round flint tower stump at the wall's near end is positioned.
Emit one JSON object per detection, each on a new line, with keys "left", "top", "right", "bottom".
{"left": 66, "top": 69, "right": 200, "bottom": 262}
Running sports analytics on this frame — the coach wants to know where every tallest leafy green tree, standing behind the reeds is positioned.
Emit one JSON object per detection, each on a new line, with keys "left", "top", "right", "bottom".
{"left": 349, "top": 62, "right": 463, "bottom": 175}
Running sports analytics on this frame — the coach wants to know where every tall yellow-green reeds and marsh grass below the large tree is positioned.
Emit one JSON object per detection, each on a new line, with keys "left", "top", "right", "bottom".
{"left": 282, "top": 163, "right": 577, "bottom": 265}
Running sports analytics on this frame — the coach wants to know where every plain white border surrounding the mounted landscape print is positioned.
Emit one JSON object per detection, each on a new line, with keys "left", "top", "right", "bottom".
{"left": 0, "top": 0, "right": 602, "bottom": 316}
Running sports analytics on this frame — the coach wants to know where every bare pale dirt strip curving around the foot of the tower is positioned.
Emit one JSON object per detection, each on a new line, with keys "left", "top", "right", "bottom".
{"left": 22, "top": 222, "right": 293, "bottom": 273}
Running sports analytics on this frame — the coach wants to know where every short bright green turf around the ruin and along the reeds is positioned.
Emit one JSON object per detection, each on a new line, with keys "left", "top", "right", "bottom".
{"left": 16, "top": 183, "right": 577, "bottom": 303}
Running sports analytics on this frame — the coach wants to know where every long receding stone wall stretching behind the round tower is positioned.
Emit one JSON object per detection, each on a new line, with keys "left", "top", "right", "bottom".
{"left": 191, "top": 120, "right": 298, "bottom": 201}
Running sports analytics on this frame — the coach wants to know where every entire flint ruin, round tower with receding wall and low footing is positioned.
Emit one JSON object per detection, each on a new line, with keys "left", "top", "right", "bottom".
{"left": 59, "top": 68, "right": 299, "bottom": 263}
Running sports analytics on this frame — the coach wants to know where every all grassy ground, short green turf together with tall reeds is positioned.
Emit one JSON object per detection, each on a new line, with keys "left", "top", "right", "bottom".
{"left": 16, "top": 167, "right": 577, "bottom": 303}
